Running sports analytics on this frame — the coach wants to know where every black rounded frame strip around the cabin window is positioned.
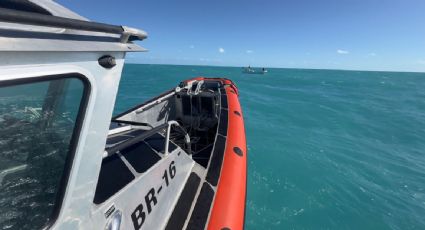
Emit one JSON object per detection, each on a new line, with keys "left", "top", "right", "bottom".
{"left": 0, "top": 72, "right": 92, "bottom": 229}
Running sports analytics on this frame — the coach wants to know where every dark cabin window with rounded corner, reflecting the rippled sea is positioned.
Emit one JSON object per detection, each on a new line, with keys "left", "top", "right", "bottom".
{"left": 0, "top": 74, "right": 88, "bottom": 229}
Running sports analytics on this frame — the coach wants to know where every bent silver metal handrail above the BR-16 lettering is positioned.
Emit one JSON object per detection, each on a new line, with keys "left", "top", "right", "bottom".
{"left": 103, "top": 121, "right": 192, "bottom": 158}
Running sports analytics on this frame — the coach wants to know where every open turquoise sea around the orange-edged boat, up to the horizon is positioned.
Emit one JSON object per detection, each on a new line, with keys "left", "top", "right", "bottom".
{"left": 115, "top": 65, "right": 425, "bottom": 229}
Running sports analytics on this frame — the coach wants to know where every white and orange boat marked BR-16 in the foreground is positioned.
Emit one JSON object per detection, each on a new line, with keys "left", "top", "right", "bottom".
{"left": 0, "top": 0, "right": 247, "bottom": 230}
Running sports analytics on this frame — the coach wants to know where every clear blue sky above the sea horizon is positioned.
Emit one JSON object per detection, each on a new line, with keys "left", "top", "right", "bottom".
{"left": 57, "top": 0, "right": 425, "bottom": 72}
